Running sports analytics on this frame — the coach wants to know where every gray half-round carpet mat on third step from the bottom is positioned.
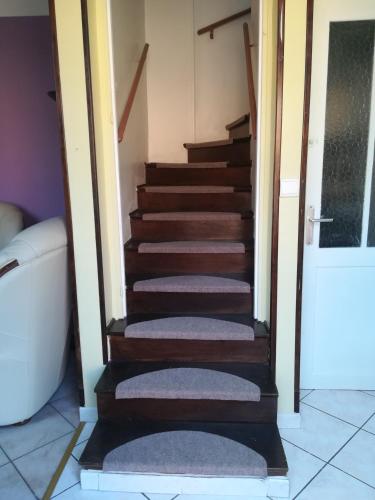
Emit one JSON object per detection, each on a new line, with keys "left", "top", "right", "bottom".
{"left": 125, "top": 316, "right": 254, "bottom": 341}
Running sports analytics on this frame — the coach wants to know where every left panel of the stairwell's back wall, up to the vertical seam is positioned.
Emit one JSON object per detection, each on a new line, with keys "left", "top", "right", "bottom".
{"left": 145, "top": 0, "right": 194, "bottom": 162}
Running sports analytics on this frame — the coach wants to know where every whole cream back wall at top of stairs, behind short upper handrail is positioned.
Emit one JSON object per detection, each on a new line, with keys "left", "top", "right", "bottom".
{"left": 145, "top": 0, "right": 257, "bottom": 161}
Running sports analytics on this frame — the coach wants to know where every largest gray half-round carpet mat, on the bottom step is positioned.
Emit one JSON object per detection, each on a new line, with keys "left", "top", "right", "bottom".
{"left": 103, "top": 431, "right": 267, "bottom": 478}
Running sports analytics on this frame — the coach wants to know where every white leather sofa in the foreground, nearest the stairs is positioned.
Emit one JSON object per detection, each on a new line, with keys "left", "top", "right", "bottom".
{"left": 0, "top": 218, "right": 70, "bottom": 425}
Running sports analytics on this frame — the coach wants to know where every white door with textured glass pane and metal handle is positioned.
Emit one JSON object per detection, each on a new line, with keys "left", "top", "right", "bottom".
{"left": 301, "top": 0, "right": 375, "bottom": 390}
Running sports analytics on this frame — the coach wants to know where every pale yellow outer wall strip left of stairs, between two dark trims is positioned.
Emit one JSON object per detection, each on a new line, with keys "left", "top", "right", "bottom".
{"left": 55, "top": 0, "right": 103, "bottom": 406}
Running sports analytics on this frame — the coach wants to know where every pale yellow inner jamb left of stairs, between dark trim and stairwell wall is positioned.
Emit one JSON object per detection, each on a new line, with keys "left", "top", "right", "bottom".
{"left": 88, "top": 0, "right": 124, "bottom": 323}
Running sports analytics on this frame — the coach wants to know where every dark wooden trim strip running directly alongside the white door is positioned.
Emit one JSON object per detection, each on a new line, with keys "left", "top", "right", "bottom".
{"left": 294, "top": 0, "right": 314, "bottom": 413}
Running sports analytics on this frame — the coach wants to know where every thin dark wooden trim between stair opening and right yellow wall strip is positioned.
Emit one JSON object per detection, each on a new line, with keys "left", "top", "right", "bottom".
{"left": 270, "top": 0, "right": 285, "bottom": 372}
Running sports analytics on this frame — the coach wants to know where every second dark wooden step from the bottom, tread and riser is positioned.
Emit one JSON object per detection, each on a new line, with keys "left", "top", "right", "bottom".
{"left": 95, "top": 362, "right": 277, "bottom": 423}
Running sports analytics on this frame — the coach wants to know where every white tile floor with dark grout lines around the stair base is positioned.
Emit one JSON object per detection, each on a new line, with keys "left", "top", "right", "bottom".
{"left": 0, "top": 365, "right": 375, "bottom": 500}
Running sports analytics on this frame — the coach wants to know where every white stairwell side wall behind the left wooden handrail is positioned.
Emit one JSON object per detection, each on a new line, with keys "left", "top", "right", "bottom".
{"left": 110, "top": 0, "right": 148, "bottom": 241}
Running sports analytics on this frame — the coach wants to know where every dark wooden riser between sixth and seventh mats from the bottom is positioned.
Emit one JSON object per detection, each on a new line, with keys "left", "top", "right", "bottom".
{"left": 138, "top": 191, "right": 251, "bottom": 212}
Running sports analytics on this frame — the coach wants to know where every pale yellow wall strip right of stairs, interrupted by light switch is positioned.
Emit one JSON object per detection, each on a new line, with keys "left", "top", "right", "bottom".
{"left": 276, "top": 0, "right": 306, "bottom": 413}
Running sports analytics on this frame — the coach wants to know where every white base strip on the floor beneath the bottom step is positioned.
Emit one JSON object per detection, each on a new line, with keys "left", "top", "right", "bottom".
{"left": 81, "top": 469, "right": 289, "bottom": 500}
